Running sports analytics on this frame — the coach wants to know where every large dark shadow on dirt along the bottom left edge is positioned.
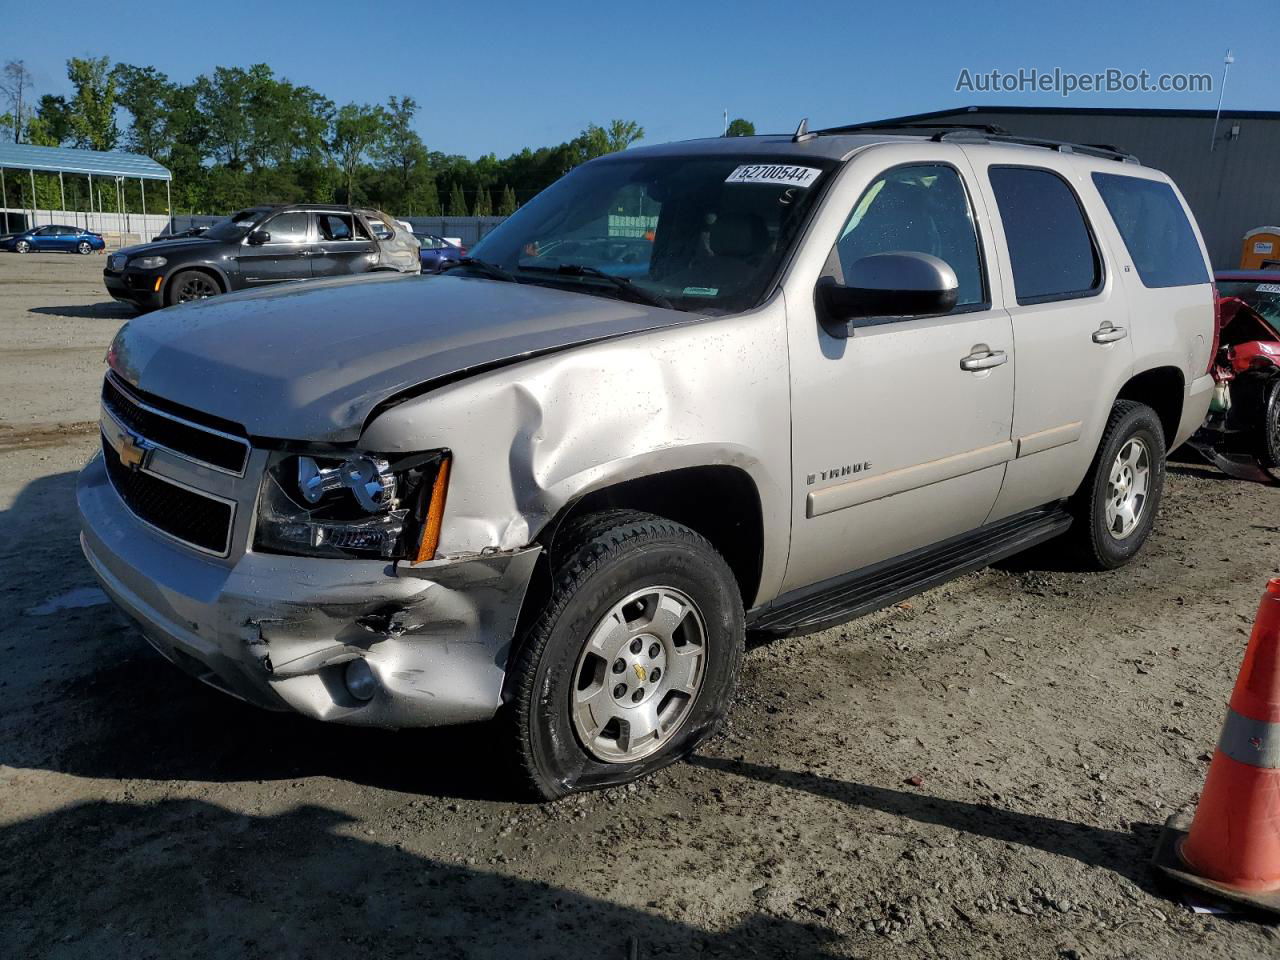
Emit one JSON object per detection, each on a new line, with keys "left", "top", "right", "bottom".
{"left": 0, "top": 800, "right": 835, "bottom": 960}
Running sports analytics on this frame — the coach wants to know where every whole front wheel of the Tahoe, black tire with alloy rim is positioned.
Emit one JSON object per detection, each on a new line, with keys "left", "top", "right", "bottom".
{"left": 504, "top": 511, "right": 745, "bottom": 800}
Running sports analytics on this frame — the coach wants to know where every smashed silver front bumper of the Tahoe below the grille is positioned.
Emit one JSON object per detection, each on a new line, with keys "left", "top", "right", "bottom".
{"left": 77, "top": 457, "right": 540, "bottom": 727}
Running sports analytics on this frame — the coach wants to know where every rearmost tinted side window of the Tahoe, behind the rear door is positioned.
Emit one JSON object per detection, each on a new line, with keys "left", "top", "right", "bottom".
{"left": 1093, "top": 173, "right": 1208, "bottom": 287}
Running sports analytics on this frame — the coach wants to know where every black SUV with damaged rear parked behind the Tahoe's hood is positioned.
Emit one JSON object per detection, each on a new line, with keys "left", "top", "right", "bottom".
{"left": 102, "top": 204, "right": 421, "bottom": 310}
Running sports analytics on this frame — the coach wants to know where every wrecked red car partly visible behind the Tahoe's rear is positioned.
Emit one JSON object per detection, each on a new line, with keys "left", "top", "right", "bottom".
{"left": 1190, "top": 270, "right": 1280, "bottom": 483}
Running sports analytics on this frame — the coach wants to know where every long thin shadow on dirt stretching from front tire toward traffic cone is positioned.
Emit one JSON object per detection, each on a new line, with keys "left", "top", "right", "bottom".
{"left": 689, "top": 755, "right": 1160, "bottom": 891}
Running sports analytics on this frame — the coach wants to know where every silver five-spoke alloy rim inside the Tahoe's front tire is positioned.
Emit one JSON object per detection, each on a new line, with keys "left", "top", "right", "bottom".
{"left": 570, "top": 586, "right": 708, "bottom": 763}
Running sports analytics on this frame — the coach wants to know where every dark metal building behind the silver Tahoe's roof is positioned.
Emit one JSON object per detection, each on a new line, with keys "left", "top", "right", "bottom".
{"left": 855, "top": 106, "right": 1280, "bottom": 269}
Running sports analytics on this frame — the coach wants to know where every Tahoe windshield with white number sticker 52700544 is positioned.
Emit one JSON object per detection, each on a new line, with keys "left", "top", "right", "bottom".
{"left": 474, "top": 156, "right": 835, "bottom": 314}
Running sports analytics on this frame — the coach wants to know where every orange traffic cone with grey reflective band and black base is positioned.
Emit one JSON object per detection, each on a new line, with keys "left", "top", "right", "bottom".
{"left": 1155, "top": 577, "right": 1280, "bottom": 913}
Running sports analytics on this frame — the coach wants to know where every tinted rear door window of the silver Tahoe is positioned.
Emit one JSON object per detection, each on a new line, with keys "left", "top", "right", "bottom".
{"left": 988, "top": 166, "right": 1102, "bottom": 303}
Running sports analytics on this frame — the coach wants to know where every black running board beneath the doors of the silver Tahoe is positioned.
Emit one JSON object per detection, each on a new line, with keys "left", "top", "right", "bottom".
{"left": 746, "top": 506, "right": 1071, "bottom": 636}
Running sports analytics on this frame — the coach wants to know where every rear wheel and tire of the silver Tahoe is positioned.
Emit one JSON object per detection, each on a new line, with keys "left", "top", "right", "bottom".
{"left": 1068, "top": 401, "right": 1166, "bottom": 570}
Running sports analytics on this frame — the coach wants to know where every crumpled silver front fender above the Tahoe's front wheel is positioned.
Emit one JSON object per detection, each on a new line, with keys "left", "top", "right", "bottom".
{"left": 360, "top": 294, "right": 791, "bottom": 603}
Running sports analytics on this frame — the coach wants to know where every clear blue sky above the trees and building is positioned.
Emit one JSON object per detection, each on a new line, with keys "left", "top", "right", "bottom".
{"left": 0, "top": 0, "right": 1280, "bottom": 157}
